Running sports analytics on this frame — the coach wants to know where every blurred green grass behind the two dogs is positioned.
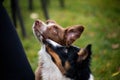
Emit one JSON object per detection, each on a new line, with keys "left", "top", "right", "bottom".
{"left": 4, "top": 0, "right": 120, "bottom": 80}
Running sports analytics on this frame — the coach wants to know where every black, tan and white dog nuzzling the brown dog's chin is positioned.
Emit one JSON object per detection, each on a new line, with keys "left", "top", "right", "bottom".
{"left": 45, "top": 39, "right": 94, "bottom": 80}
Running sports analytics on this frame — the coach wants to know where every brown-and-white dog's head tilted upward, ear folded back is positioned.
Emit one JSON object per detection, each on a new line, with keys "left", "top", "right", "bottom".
{"left": 33, "top": 20, "right": 84, "bottom": 46}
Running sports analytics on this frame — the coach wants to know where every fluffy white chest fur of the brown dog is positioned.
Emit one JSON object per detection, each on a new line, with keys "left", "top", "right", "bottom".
{"left": 39, "top": 46, "right": 70, "bottom": 80}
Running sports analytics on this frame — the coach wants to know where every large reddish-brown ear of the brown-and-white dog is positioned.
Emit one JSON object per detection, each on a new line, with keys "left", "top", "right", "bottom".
{"left": 65, "top": 25, "right": 84, "bottom": 46}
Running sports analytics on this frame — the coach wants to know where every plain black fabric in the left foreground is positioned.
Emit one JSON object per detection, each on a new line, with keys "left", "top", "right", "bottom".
{"left": 0, "top": 2, "right": 34, "bottom": 80}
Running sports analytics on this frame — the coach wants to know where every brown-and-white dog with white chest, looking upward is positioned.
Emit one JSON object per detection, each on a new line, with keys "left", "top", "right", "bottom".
{"left": 32, "top": 20, "right": 84, "bottom": 80}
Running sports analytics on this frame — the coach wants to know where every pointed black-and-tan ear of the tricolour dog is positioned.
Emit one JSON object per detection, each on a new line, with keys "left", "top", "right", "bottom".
{"left": 77, "top": 44, "right": 91, "bottom": 62}
